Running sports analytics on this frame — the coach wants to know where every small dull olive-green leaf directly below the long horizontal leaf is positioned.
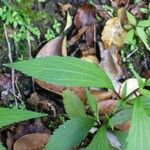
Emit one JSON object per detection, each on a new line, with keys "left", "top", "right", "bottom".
{"left": 63, "top": 90, "right": 86, "bottom": 118}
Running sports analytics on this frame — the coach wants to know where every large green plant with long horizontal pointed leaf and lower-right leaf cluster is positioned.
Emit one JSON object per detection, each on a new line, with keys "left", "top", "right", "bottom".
{"left": 5, "top": 56, "right": 150, "bottom": 150}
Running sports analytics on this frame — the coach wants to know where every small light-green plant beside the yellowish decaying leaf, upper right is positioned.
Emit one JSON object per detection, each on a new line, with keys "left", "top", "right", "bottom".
{"left": 124, "top": 12, "right": 150, "bottom": 51}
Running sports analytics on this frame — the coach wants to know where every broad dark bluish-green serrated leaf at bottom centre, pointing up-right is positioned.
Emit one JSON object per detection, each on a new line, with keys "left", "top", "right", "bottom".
{"left": 46, "top": 117, "right": 94, "bottom": 150}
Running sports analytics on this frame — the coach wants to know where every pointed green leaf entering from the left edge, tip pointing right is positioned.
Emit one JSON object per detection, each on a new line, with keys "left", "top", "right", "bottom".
{"left": 0, "top": 107, "right": 47, "bottom": 128}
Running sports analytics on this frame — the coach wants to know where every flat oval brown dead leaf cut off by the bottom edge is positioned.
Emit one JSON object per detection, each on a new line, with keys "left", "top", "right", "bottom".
{"left": 14, "top": 133, "right": 49, "bottom": 150}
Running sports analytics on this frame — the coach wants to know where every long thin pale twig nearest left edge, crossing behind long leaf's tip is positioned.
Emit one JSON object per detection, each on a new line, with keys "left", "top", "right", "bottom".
{"left": 3, "top": 24, "right": 18, "bottom": 108}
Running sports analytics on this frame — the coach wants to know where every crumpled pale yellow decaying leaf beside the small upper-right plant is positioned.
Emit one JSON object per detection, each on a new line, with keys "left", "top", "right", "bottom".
{"left": 102, "top": 9, "right": 127, "bottom": 49}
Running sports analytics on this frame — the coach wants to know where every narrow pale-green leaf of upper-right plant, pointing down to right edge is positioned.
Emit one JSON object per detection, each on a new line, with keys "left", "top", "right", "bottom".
{"left": 136, "top": 27, "right": 150, "bottom": 51}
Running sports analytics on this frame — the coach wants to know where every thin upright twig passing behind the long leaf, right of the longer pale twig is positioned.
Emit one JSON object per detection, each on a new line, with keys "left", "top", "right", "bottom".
{"left": 27, "top": 30, "right": 35, "bottom": 91}
